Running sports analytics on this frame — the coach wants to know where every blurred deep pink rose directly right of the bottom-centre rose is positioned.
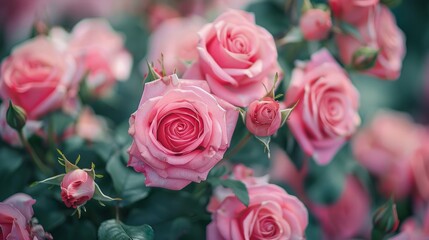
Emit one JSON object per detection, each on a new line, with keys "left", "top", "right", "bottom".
{"left": 310, "top": 176, "right": 370, "bottom": 240}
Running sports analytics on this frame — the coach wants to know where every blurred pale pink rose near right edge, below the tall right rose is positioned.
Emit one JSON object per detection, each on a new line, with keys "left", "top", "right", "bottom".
{"left": 352, "top": 111, "right": 420, "bottom": 198}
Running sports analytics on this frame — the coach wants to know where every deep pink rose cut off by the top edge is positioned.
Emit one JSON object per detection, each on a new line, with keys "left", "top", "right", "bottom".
{"left": 329, "top": 0, "right": 379, "bottom": 24}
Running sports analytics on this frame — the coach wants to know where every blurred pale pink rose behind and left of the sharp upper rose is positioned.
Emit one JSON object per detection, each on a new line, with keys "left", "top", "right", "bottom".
{"left": 146, "top": 16, "right": 205, "bottom": 74}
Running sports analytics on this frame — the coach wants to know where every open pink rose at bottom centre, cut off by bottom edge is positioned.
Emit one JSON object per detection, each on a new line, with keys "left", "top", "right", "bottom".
{"left": 207, "top": 184, "right": 308, "bottom": 240}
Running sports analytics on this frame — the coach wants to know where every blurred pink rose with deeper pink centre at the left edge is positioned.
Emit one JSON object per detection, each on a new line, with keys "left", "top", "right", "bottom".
{"left": 0, "top": 36, "right": 79, "bottom": 119}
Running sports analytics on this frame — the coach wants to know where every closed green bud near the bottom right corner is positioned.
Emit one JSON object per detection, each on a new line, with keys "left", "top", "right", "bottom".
{"left": 372, "top": 199, "right": 399, "bottom": 234}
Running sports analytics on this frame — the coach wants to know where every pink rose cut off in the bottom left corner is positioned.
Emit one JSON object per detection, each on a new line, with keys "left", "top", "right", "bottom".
{"left": 0, "top": 193, "right": 37, "bottom": 240}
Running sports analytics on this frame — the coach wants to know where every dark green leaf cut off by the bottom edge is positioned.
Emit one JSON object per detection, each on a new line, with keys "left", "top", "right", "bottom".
{"left": 98, "top": 219, "right": 154, "bottom": 240}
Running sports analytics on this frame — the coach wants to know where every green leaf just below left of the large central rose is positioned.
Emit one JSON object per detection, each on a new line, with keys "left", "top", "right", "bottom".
{"left": 106, "top": 155, "right": 150, "bottom": 206}
